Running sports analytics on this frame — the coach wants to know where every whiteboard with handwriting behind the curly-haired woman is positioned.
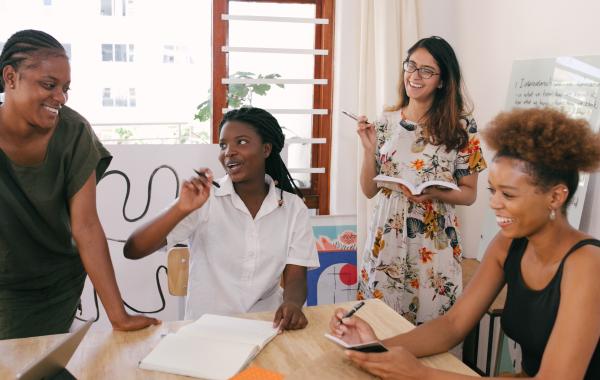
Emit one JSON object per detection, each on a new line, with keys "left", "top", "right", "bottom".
{"left": 477, "top": 56, "right": 600, "bottom": 260}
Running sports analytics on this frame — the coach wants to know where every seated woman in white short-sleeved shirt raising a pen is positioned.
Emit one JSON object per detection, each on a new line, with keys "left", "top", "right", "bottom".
{"left": 124, "top": 108, "right": 319, "bottom": 330}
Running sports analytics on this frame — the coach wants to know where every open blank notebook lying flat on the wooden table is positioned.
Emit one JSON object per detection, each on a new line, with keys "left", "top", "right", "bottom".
{"left": 140, "top": 314, "right": 277, "bottom": 379}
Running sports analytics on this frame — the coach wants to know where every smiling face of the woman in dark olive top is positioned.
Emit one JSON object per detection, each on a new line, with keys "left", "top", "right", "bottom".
{"left": 3, "top": 52, "right": 71, "bottom": 129}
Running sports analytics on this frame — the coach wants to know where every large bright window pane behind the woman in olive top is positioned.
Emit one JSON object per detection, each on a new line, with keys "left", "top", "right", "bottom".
{"left": 0, "top": 0, "right": 212, "bottom": 144}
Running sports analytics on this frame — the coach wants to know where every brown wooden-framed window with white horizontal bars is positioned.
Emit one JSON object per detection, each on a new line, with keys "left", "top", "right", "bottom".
{"left": 212, "top": 0, "right": 334, "bottom": 215}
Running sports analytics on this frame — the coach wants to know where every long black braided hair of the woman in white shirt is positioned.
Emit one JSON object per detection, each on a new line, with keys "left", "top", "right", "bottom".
{"left": 219, "top": 107, "right": 303, "bottom": 198}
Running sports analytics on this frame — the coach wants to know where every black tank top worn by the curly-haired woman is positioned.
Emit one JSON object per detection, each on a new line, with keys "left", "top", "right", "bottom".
{"left": 502, "top": 238, "right": 600, "bottom": 380}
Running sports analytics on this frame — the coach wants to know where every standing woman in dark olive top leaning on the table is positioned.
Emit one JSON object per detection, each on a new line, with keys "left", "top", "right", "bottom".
{"left": 0, "top": 30, "right": 158, "bottom": 339}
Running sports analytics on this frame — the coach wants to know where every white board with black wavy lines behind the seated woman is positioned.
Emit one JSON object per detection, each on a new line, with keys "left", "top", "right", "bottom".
{"left": 77, "top": 144, "right": 225, "bottom": 327}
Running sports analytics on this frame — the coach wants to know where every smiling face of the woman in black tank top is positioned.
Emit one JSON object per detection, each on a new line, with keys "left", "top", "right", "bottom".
{"left": 489, "top": 157, "right": 563, "bottom": 238}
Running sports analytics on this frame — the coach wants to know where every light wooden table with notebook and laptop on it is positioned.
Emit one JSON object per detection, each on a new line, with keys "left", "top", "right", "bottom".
{"left": 0, "top": 300, "right": 477, "bottom": 379}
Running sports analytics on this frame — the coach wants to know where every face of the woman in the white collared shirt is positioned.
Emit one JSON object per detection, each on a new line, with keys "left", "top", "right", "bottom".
{"left": 219, "top": 121, "right": 271, "bottom": 183}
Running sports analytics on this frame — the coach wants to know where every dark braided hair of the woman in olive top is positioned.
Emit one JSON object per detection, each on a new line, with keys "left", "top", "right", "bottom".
{"left": 0, "top": 29, "right": 66, "bottom": 92}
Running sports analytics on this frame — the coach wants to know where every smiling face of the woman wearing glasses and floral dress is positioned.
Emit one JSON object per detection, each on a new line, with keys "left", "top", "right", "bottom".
{"left": 404, "top": 48, "right": 440, "bottom": 102}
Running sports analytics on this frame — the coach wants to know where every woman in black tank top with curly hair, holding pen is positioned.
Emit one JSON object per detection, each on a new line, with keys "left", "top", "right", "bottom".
{"left": 330, "top": 109, "right": 600, "bottom": 380}
